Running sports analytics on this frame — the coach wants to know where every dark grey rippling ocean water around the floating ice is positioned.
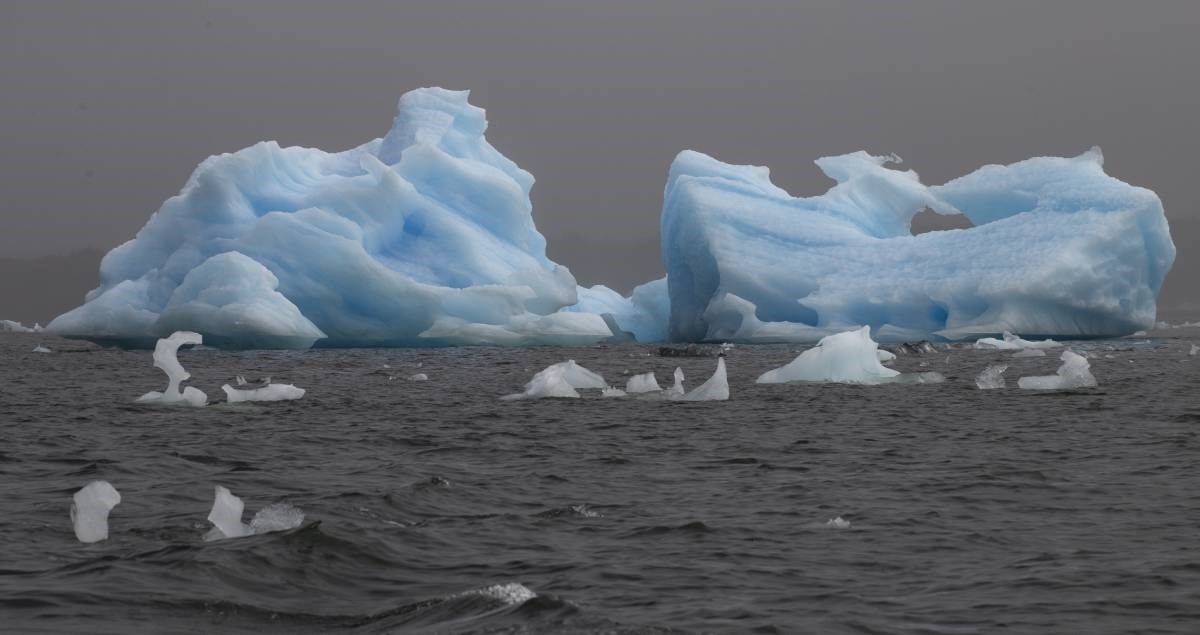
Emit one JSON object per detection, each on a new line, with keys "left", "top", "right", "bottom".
{"left": 0, "top": 329, "right": 1200, "bottom": 634}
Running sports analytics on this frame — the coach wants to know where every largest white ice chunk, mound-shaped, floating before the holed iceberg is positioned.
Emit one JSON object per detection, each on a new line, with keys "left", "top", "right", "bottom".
{"left": 756, "top": 327, "right": 900, "bottom": 384}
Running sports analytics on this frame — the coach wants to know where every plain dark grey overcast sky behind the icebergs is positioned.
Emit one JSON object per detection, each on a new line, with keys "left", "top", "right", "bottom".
{"left": 0, "top": 0, "right": 1200, "bottom": 317}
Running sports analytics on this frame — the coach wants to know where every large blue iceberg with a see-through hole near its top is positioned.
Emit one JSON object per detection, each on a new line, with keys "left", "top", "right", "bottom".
{"left": 657, "top": 149, "right": 1175, "bottom": 342}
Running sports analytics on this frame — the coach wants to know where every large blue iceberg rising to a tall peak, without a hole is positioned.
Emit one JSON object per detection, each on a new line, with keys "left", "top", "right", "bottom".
{"left": 49, "top": 88, "right": 612, "bottom": 348}
